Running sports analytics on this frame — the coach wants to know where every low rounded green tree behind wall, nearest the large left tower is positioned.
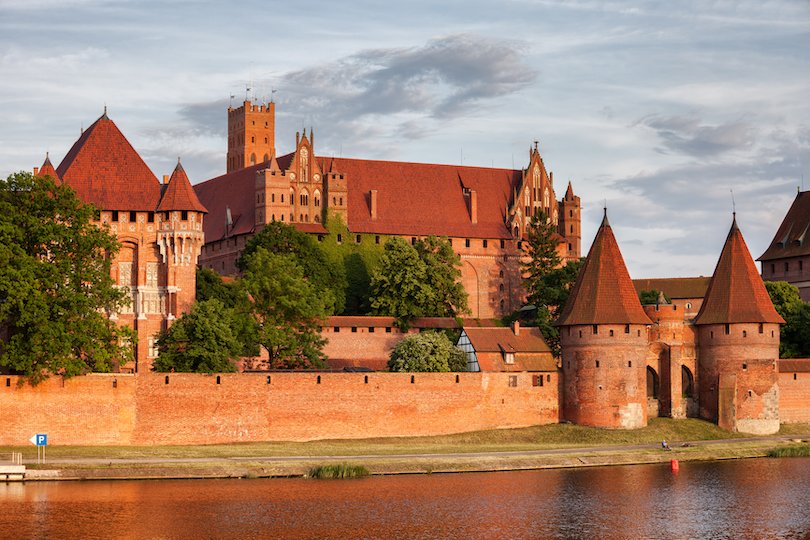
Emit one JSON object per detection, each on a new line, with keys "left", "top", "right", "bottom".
{"left": 152, "top": 299, "right": 241, "bottom": 373}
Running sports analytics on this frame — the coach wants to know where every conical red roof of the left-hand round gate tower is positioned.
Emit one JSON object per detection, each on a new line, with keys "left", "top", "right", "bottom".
{"left": 555, "top": 211, "right": 652, "bottom": 326}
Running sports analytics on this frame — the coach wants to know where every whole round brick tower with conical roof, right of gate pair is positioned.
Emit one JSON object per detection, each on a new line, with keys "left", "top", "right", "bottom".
{"left": 695, "top": 216, "right": 785, "bottom": 435}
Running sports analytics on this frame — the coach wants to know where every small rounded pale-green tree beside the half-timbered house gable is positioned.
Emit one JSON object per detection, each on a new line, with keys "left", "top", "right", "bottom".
{"left": 388, "top": 332, "right": 467, "bottom": 372}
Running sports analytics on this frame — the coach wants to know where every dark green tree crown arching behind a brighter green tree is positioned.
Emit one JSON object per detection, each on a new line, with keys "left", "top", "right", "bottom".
{"left": 236, "top": 221, "right": 346, "bottom": 313}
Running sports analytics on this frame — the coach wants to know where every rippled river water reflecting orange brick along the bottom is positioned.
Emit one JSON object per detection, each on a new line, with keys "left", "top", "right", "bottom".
{"left": 0, "top": 458, "right": 810, "bottom": 539}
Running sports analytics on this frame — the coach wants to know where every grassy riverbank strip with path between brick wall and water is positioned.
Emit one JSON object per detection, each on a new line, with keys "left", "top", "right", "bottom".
{"left": 7, "top": 419, "right": 810, "bottom": 480}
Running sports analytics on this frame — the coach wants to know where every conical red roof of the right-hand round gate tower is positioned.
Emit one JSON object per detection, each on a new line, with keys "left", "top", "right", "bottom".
{"left": 695, "top": 216, "right": 785, "bottom": 324}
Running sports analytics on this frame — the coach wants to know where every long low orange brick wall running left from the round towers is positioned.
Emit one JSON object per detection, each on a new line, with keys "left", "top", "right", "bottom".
{"left": 0, "top": 372, "right": 560, "bottom": 446}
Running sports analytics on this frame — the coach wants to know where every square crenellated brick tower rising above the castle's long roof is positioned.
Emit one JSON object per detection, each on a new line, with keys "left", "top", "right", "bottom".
{"left": 227, "top": 101, "right": 276, "bottom": 172}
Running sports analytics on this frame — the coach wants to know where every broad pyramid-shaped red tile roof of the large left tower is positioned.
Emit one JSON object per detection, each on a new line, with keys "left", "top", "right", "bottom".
{"left": 56, "top": 113, "right": 160, "bottom": 211}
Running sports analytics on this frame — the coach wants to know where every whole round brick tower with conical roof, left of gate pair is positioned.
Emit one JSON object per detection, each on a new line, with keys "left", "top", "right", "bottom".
{"left": 556, "top": 211, "right": 651, "bottom": 429}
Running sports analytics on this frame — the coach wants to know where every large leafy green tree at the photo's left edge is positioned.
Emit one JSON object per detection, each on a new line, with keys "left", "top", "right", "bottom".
{"left": 0, "top": 172, "right": 134, "bottom": 384}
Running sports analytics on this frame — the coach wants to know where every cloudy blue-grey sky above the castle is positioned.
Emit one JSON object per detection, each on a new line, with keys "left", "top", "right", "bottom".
{"left": 0, "top": 0, "right": 810, "bottom": 277}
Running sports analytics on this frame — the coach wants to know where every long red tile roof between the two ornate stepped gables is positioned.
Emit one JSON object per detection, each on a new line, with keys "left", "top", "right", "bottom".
{"left": 320, "top": 158, "right": 522, "bottom": 239}
